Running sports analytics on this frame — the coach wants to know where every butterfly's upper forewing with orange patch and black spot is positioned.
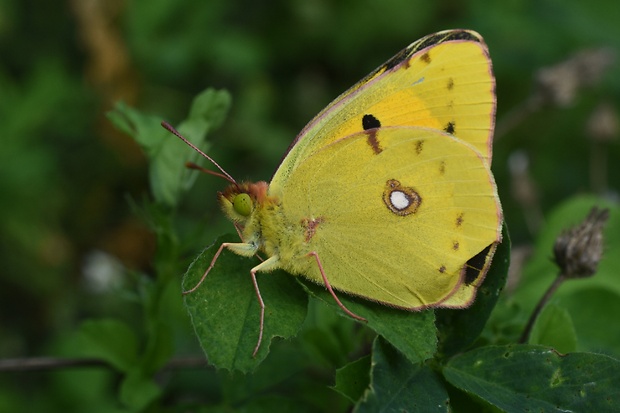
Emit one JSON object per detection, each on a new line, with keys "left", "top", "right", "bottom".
{"left": 272, "top": 30, "right": 496, "bottom": 185}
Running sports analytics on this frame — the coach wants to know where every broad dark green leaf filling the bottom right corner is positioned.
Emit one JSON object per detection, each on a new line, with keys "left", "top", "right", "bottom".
{"left": 443, "top": 345, "right": 620, "bottom": 413}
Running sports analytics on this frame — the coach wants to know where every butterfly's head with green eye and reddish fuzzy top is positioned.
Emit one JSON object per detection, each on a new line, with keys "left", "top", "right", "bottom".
{"left": 217, "top": 181, "right": 268, "bottom": 225}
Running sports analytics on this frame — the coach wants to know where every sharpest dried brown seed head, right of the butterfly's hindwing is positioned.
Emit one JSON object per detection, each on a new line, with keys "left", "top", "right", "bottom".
{"left": 553, "top": 207, "right": 609, "bottom": 278}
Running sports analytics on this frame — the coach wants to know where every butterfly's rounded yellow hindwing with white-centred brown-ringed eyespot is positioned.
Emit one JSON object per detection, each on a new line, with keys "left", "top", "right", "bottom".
{"left": 274, "top": 127, "right": 502, "bottom": 309}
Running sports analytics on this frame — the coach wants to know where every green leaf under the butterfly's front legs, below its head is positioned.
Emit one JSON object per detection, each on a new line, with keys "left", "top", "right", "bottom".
{"left": 183, "top": 235, "right": 308, "bottom": 372}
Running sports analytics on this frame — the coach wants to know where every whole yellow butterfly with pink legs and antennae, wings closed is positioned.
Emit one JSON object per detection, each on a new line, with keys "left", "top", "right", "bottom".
{"left": 164, "top": 30, "right": 502, "bottom": 354}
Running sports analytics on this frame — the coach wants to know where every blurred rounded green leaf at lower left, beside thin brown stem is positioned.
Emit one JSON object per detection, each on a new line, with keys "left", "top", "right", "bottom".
{"left": 79, "top": 319, "right": 138, "bottom": 372}
